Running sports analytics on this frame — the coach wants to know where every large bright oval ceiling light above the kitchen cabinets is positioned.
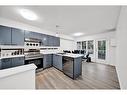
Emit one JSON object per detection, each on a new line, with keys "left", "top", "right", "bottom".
{"left": 20, "top": 9, "right": 38, "bottom": 20}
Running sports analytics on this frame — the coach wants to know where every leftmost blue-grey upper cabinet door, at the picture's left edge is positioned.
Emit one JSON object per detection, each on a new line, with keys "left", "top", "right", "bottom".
{"left": 0, "top": 26, "right": 11, "bottom": 45}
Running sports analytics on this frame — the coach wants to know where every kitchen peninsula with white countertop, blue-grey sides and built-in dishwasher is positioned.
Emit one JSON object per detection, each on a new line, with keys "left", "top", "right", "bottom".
{"left": 53, "top": 53, "right": 83, "bottom": 79}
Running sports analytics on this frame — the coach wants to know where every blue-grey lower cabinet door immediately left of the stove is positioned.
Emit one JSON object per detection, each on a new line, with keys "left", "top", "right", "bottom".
{"left": 11, "top": 57, "right": 24, "bottom": 67}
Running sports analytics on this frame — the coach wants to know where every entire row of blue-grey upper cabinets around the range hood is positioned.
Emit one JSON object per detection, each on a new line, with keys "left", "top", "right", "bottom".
{"left": 0, "top": 26, "right": 60, "bottom": 46}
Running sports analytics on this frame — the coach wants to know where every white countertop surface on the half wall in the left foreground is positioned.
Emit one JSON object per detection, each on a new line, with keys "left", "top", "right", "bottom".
{"left": 0, "top": 64, "right": 37, "bottom": 78}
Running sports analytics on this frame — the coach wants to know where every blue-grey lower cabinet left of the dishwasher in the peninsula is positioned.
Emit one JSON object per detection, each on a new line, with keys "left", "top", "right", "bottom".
{"left": 53, "top": 54, "right": 63, "bottom": 71}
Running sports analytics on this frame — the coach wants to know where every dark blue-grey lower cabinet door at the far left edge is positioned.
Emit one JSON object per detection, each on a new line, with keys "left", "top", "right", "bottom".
{"left": 1, "top": 58, "right": 12, "bottom": 69}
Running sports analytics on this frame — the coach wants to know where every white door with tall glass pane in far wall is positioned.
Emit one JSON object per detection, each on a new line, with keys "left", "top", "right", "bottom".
{"left": 95, "top": 39, "right": 107, "bottom": 63}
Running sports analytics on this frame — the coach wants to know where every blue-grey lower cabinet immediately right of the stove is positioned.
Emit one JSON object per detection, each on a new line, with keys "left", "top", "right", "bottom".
{"left": 43, "top": 54, "right": 53, "bottom": 69}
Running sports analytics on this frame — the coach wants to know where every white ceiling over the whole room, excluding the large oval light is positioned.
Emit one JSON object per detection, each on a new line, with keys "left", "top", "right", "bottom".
{"left": 0, "top": 6, "right": 120, "bottom": 35}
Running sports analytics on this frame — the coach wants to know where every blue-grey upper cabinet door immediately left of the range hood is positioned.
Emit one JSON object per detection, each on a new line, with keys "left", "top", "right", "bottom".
{"left": 12, "top": 28, "right": 24, "bottom": 46}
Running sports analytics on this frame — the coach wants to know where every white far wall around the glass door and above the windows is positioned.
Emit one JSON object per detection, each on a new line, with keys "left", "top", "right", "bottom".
{"left": 76, "top": 31, "right": 116, "bottom": 65}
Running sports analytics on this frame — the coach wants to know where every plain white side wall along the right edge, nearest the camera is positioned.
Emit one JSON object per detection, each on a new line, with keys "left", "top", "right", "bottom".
{"left": 116, "top": 7, "right": 127, "bottom": 89}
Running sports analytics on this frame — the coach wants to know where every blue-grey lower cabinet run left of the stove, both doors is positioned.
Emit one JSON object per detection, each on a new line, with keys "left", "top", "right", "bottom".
{"left": 0, "top": 57, "right": 24, "bottom": 69}
